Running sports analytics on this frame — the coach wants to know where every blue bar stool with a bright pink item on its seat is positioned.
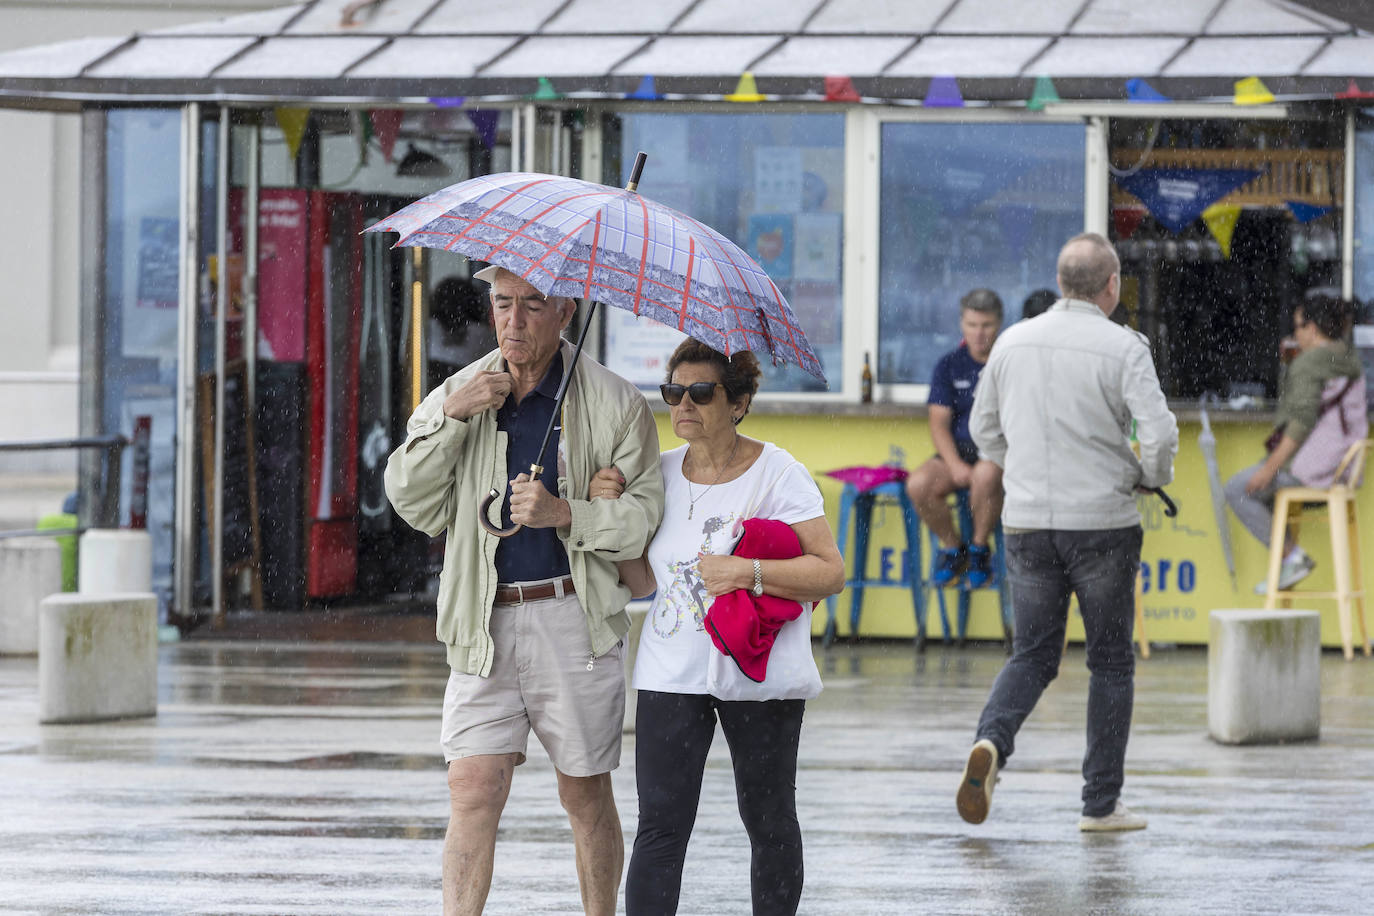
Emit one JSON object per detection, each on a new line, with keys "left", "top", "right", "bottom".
{"left": 822, "top": 481, "right": 926, "bottom": 648}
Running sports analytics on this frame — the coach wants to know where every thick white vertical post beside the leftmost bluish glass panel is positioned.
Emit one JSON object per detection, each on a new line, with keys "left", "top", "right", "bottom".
{"left": 172, "top": 102, "right": 201, "bottom": 617}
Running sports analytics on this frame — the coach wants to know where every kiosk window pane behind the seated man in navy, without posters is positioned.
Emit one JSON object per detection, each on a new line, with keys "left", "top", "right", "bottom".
{"left": 875, "top": 124, "right": 1084, "bottom": 385}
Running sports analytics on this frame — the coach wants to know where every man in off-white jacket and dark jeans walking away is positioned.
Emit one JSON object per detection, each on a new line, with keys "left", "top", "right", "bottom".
{"left": 956, "top": 233, "right": 1179, "bottom": 831}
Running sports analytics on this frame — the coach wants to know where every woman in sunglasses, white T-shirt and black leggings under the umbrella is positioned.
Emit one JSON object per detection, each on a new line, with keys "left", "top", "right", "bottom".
{"left": 591, "top": 339, "right": 844, "bottom": 916}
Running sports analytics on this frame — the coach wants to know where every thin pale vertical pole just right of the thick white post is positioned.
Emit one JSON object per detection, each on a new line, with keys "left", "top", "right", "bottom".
{"left": 210, "top": 108, "right": 231, "bottom": 626}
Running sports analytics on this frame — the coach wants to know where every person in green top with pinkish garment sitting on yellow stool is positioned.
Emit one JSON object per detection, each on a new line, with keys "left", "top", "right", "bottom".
{"left": 1226, "top": 297, "right": 1370, "bottom": 595}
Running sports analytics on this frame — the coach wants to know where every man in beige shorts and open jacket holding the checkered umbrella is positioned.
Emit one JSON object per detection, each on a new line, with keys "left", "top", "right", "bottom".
{"left": 386, "top": 266, "right": 664, "bottom": 915}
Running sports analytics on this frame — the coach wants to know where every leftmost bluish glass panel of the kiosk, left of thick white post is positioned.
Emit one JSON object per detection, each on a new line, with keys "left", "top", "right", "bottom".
{"left": 102, "top": 108, "right": 181, "bottom": 608}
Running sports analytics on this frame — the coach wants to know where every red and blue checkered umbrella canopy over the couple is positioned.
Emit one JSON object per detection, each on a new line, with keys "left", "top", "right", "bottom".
{"left": 368, "top": 172, "right": 826, "bottom": 380}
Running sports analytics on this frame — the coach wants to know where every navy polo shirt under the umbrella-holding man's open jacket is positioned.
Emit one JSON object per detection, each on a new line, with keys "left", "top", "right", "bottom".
{"left": 496, "top": 353, "right": 567, "bottom": 582}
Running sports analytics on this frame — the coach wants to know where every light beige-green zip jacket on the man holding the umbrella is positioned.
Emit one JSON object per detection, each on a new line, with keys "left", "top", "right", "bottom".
{"left": 386, "top": 341, "right": 664, "bottom": 677}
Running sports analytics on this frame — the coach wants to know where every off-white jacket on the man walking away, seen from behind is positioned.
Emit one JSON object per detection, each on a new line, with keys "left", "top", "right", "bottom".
{"left": 969, "top": 299, "right": 1179, "bottom": 530}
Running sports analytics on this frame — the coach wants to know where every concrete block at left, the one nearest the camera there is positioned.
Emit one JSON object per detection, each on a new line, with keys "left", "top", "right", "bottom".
{"left": 38, "top": 593, "right": 158, "bottom": 722}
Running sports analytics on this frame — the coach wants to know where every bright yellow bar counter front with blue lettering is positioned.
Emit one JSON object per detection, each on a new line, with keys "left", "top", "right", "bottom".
{"left": 657, "top": 405, "right": 1374, "bottom": 647}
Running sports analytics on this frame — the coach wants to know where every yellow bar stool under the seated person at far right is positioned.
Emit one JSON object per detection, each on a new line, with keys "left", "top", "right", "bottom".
{"left": 1264, "top": 439, "right": 1371, "bottom": 661}
